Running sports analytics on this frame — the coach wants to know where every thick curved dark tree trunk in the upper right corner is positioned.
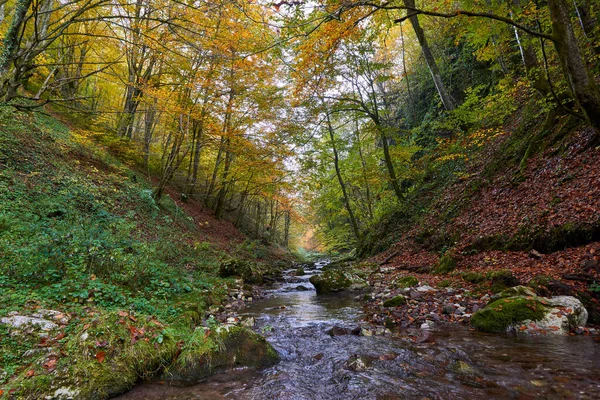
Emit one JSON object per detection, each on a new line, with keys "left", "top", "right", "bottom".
{"left": 548, "top": 0, "right": 600, "bottom": 130}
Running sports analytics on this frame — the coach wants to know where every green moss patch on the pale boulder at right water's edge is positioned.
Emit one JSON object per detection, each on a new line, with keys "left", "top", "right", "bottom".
{"left": 471, "top": 297, "right": 545, "bottom": 333}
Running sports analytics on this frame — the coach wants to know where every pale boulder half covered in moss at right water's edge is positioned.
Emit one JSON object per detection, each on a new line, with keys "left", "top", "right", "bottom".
{"left": 471, "top": 294, "right": 588, "bottom": 335}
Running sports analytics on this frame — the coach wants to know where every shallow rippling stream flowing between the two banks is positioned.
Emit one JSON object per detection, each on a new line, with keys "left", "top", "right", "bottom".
{"left": 119, "top": 262, "right": 600, "bottom": 400}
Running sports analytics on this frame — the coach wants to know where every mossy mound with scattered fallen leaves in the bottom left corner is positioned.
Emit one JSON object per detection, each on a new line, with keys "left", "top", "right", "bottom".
{"left": 11, "top": 312, "right": 179, "bottom": 400}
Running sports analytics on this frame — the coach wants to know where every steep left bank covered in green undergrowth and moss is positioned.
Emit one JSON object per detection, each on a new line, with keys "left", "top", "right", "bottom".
{"left": 0, "top": 107, "right": 289, "bottom": 399}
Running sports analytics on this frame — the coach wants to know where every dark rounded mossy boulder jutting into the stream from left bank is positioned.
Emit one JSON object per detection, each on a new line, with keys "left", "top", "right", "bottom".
{"left": 160, "top": 326, "right": 279, "bottom": 386}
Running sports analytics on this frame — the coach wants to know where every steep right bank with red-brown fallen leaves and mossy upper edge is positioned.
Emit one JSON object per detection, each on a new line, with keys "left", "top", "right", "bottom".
{"left": 362, "top": 107, "right": 600, "bottom": 327}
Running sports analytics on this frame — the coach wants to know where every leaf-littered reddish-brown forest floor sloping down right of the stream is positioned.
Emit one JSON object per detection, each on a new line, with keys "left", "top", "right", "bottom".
{"left": 360, "top": 120, "right": 600, "bottom": 334}
